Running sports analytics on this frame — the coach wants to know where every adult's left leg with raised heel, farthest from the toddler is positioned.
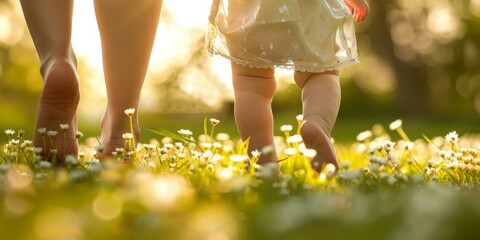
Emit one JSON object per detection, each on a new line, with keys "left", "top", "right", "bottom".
{"left": 21, "top": 0, "right": 80, "bottom": 163}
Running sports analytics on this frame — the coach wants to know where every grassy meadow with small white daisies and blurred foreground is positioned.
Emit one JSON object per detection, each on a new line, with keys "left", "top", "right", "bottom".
{"left": 0, "top": 113, "right": 480, "bottom": 240}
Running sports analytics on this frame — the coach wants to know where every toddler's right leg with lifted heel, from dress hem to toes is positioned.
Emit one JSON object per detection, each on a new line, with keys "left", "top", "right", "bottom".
{"left": 295, "top": 71, "right": 341, "bottom": 171}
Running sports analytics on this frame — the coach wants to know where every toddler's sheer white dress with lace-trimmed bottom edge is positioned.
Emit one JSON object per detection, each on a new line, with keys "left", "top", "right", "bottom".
{"left": 206, "top": 0, "right": 358, "bottom": 72}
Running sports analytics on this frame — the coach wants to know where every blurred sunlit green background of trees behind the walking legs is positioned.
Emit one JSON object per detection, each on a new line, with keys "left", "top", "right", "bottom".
{"left": 0, "top": 0, "right": 480, "bottom": 143}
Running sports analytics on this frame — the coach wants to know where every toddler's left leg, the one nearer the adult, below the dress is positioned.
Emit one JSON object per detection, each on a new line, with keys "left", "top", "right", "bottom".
{"left": 232, "top": 63, "right": 278, "bottom": 163}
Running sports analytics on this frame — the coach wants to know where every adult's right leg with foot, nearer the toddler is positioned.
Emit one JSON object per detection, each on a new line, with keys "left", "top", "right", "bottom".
{"left": 95, "top": 0, "right": 162, "bottom": 155}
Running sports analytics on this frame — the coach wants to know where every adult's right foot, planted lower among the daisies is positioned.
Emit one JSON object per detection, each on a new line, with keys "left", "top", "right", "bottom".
{"left": 100, "top": 108, "right": 140, "bottom": 156}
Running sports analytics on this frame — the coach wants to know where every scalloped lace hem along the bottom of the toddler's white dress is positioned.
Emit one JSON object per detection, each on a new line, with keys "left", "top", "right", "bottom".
{"left": 209, "top": 52, "right": 360, "bottom": 73}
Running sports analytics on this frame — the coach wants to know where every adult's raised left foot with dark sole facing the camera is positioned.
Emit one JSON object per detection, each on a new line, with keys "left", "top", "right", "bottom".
{"left": 34, "top": 57, "right": 80, "bottom": 164}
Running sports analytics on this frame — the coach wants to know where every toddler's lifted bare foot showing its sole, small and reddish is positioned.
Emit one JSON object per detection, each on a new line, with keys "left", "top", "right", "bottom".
{"left": 300, "top": 120, "right": 338, "bottom": 172}
